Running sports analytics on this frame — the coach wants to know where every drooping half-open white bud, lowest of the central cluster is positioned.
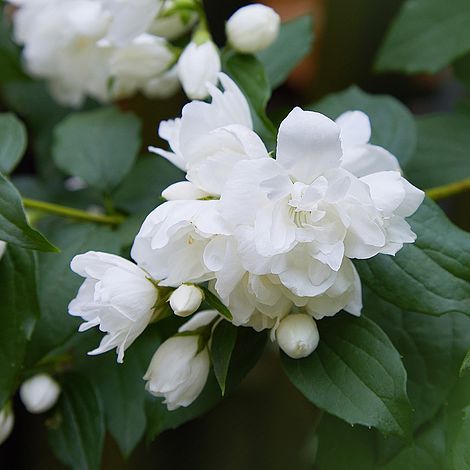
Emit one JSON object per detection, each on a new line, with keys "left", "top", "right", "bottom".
{"left": 144, "top": 335, "right": 210, "bottom": 411}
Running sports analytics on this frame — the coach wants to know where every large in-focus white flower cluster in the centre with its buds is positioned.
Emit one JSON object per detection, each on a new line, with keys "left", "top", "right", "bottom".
{"left": 70, "top": 74, "right": 424, "bottom": 409}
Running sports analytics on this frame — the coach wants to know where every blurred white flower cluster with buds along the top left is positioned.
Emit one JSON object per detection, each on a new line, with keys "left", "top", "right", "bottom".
{"left": 9, "top": 0, "right": 279, "bottom": 106}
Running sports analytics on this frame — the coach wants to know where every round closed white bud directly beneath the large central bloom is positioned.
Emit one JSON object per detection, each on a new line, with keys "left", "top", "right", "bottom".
{"left": 276, "top": 313, "right": 320, "bottom": 359}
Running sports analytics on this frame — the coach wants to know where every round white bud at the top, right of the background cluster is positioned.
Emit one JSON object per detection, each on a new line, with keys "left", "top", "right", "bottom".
{"left": 225, "top": 3, "right": 281, "bottom": 53}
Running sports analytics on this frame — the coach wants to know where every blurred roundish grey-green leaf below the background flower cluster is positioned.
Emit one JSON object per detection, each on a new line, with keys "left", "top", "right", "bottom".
{"left": 53, "top": 107, "right": 140, "bottom": 193}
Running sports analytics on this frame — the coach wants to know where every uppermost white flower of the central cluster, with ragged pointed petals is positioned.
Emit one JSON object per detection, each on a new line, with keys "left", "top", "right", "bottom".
{"left": 149, "top": 74, "right": 268, "bottom": 196}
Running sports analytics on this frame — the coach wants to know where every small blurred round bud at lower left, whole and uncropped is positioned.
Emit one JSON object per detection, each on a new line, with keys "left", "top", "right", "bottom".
{"left": 20, "top": 374, "right": 60, "bottom": 413}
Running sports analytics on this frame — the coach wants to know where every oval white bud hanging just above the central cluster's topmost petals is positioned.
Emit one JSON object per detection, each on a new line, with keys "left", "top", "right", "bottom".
{"left": 178, "top": 40, "right": 221, "bottom": 100}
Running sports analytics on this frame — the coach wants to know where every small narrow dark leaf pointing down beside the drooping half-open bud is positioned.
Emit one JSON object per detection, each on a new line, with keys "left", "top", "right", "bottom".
{"left": 211, "top": 321, "right": 237, "bottom": 395}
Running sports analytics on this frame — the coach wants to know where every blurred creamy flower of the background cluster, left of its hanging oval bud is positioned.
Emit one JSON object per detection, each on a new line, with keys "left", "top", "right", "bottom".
{"left": 109, "top": 34, "right": 173, "bottom": 98}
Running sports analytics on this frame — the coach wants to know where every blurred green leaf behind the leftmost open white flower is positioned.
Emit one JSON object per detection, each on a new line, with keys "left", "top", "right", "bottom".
{"left": 28, "top": 220, "right": 120, "bottom": 365}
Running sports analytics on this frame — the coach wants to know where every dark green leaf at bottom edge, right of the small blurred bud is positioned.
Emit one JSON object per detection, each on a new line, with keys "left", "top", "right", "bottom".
{"left": 49, "top": 375, "right": 105, "bottom": 470}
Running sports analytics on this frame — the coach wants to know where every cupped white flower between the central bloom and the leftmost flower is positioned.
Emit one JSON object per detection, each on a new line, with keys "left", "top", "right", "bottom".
{"left": 131, "top": 201, "right": 229, "bottom": 287}
